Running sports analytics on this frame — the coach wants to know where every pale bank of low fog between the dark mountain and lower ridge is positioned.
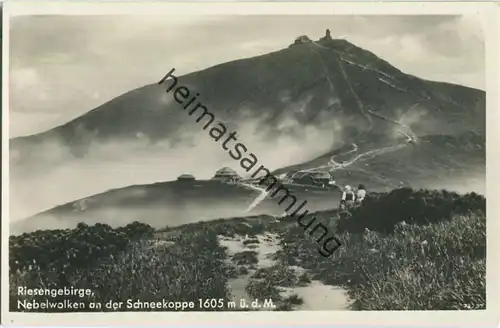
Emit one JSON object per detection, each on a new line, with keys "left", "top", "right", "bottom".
{"left": 10, "top": 109, "right": 335, "bottom": 220}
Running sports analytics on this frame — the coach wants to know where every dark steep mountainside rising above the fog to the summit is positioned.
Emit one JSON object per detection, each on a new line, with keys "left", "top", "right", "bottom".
{"left": 11, "top": 39, "right": 485, "bottom": 162}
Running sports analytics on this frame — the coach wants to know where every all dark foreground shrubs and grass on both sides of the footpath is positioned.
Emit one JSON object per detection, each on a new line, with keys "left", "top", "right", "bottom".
{"left": 9, "top": 189, "right": 486, "bottom": 312}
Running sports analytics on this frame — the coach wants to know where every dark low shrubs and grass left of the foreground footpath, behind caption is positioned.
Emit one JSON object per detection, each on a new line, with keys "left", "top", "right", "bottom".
{"left": 10, "top": 224, "right": 234, "bottom": 312}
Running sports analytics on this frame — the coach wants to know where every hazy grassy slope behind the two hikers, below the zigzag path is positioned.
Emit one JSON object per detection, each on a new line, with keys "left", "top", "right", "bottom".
{"left": 273, "top": 132, "right": 486, "bottom": 191}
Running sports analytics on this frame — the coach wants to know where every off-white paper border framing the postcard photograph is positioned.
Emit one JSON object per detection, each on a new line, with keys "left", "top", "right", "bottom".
{"left": 1, "top": 1, "right": 500, "bottom": 326}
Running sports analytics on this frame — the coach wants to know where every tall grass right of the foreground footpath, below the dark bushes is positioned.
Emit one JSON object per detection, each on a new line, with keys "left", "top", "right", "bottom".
{"left": 282, "top": 213, "right": 486, "bottom": 310}
